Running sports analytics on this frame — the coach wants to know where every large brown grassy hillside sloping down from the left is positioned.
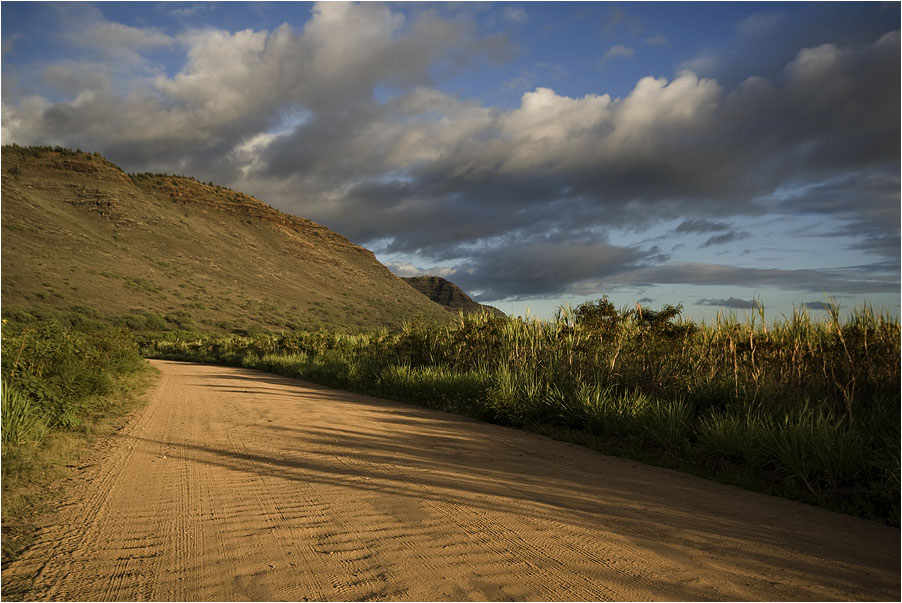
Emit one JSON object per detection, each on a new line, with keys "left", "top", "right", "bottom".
{"left": 2, "top": 147, "right": 449, "bottom": 331}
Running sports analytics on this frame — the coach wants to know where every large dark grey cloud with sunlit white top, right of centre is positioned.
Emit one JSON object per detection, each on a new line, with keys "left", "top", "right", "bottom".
{"left": 264, "top": 27, "right": 899, "bottom": 266}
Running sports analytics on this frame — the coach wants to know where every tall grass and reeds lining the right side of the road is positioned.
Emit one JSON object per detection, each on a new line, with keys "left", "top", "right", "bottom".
{"left": 142, "top": 299, "right": 900, "bottom": 525}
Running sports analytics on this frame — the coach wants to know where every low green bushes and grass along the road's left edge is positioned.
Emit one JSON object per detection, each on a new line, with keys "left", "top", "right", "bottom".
{"left": 0, "top": 319, "right": 148, "bottom": 562}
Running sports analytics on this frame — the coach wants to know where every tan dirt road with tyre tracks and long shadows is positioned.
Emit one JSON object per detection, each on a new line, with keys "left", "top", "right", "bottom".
{"left": 4, "top": 362, "right": 900, "bottom": 601}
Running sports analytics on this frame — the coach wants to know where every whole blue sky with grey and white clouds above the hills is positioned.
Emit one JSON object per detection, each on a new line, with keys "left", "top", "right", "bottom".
{"left": 0, "top": 1, "right": 902, "bottom": 321}
